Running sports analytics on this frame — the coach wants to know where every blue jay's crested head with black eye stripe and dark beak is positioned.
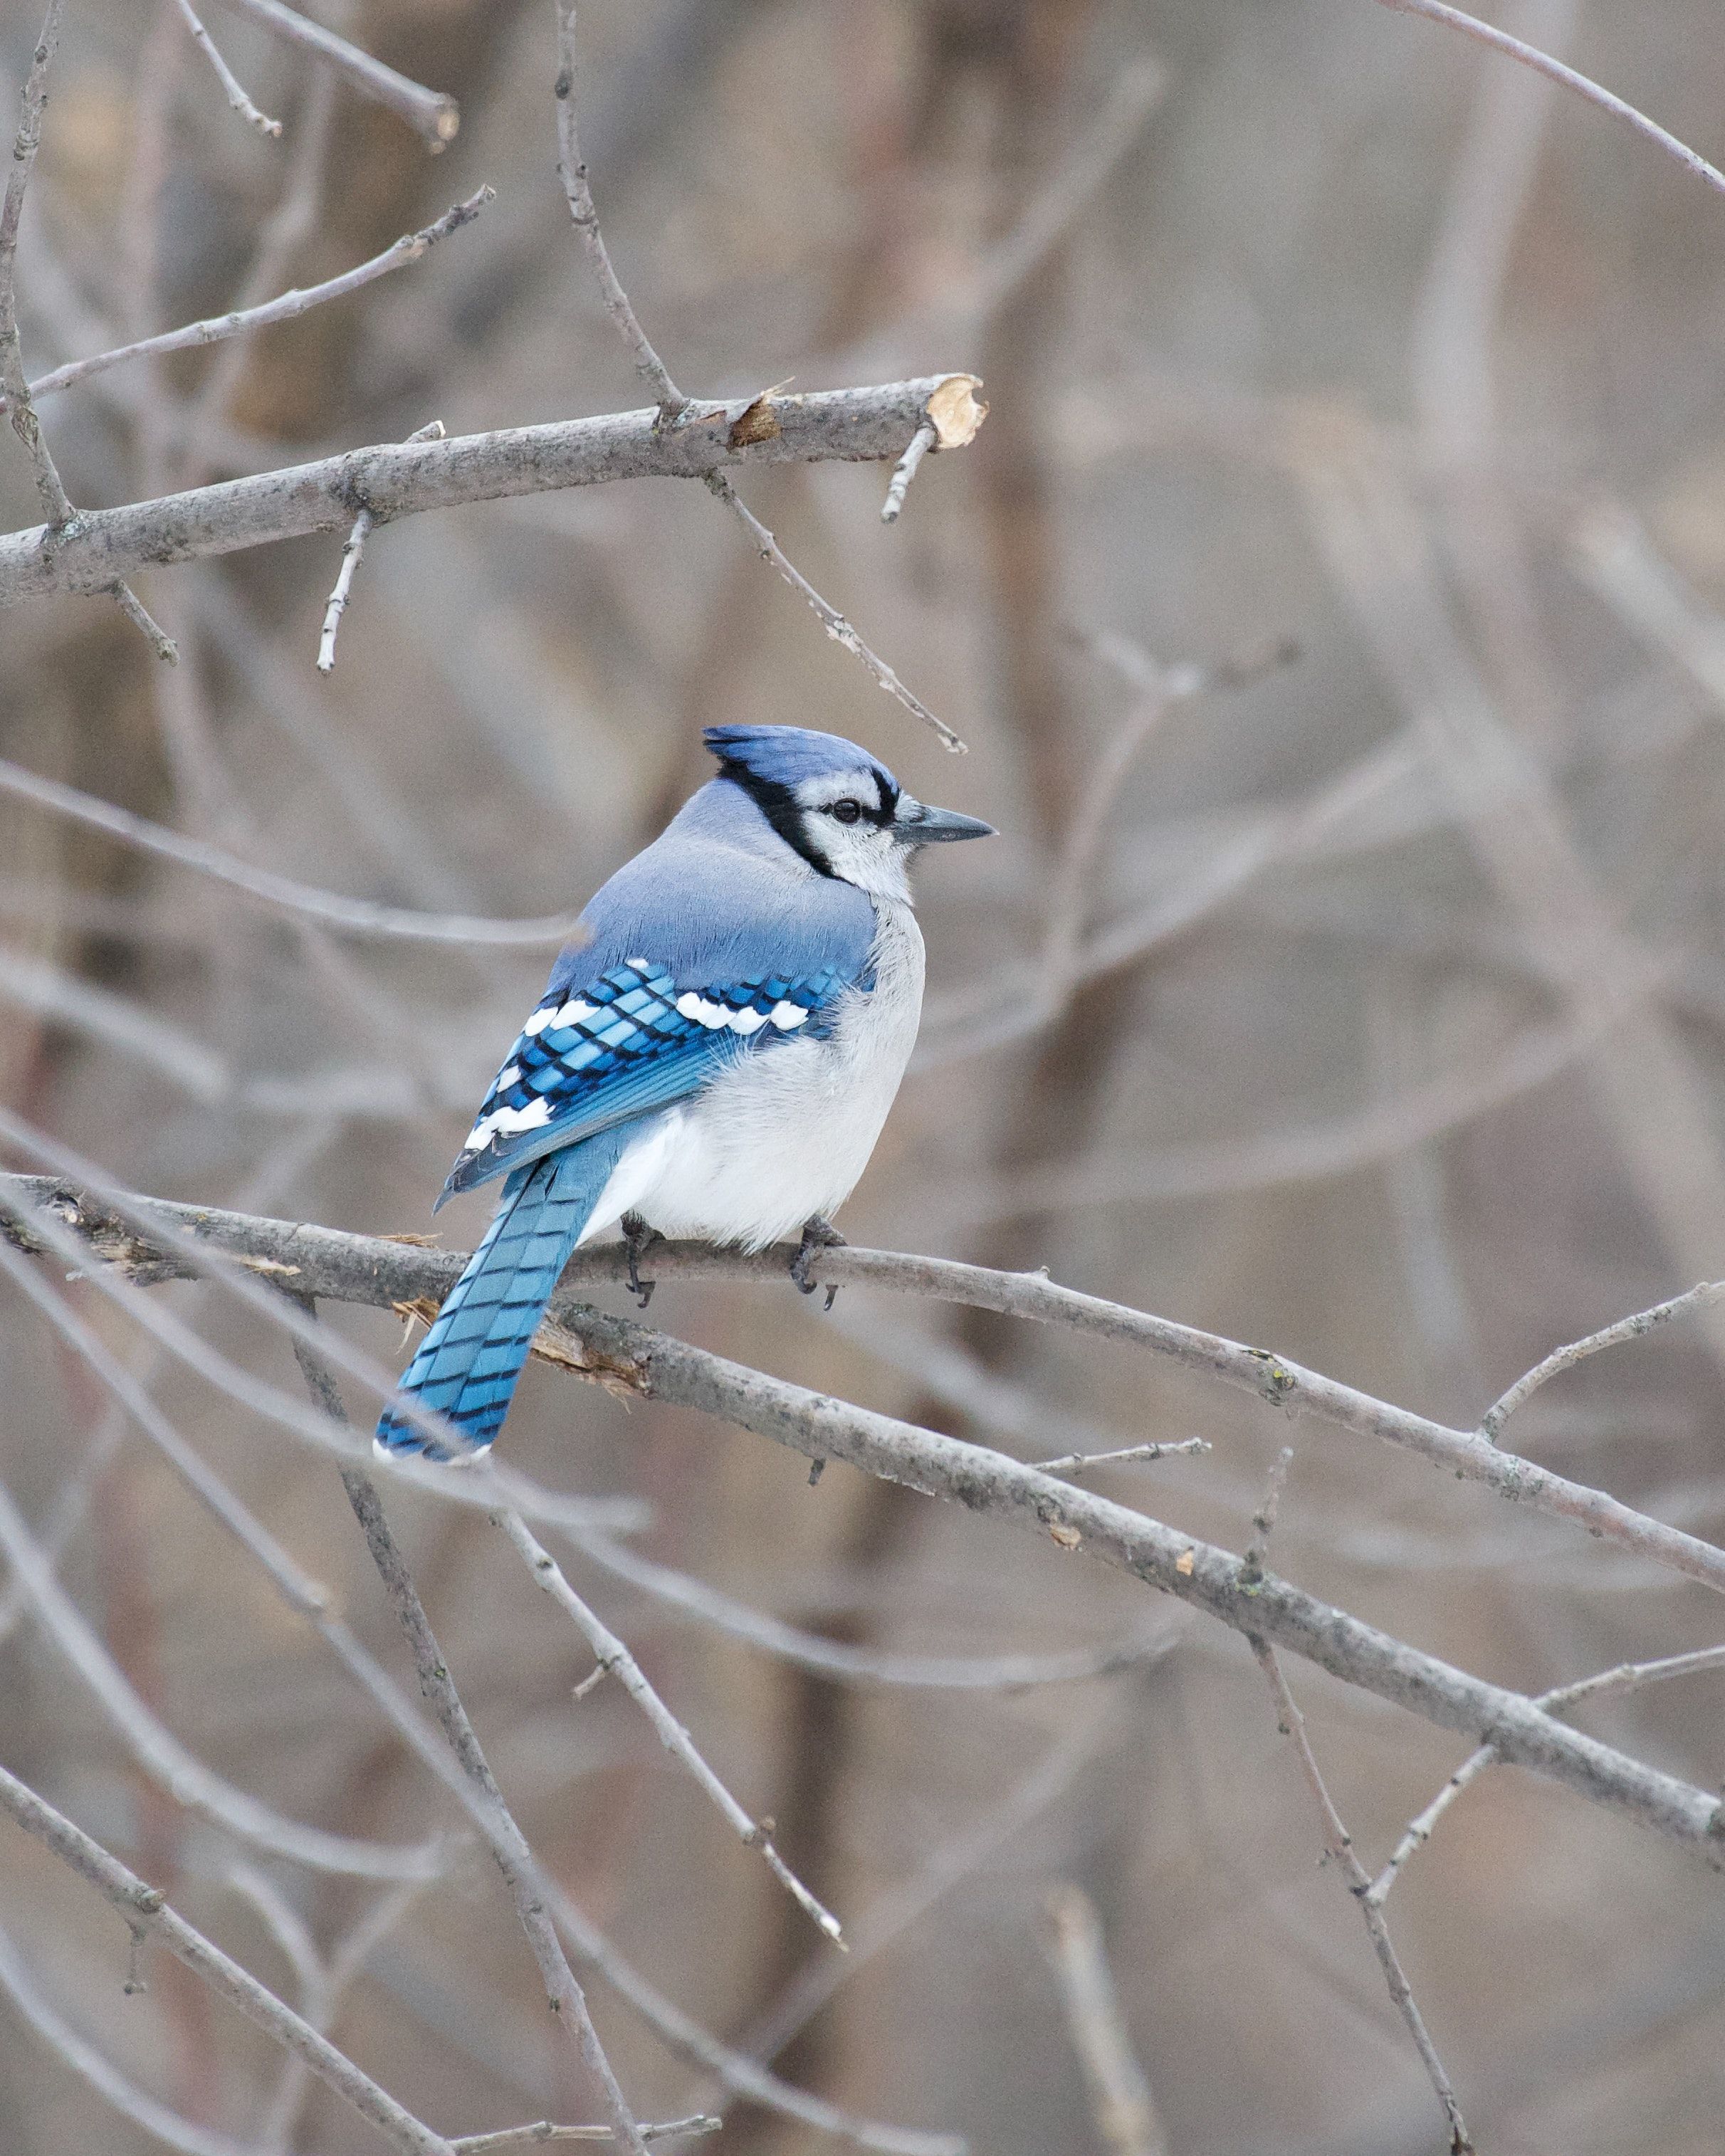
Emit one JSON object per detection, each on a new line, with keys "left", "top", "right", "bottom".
{"left": 701, "top": 727, "right": 994, "bottom": 899}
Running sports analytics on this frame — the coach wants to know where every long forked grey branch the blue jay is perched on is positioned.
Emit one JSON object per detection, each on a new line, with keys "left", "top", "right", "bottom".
{"left": 0, "top": 1177, "right": 1725, "bottom": 1852}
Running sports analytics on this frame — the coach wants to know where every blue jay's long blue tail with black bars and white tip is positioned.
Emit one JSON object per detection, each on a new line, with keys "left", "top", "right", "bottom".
{"left": 377, "top": 1127, "right": 636, "bottom": 1460}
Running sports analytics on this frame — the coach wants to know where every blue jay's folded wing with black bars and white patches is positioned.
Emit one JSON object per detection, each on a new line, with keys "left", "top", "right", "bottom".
{"left": 438, "top": 957, "right": 854, "bottom": 1205}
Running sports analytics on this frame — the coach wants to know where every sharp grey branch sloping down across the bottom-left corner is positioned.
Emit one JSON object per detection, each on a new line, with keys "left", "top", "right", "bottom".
{"left": 0, "top": 1768, "right": 451, "bottom": 2156}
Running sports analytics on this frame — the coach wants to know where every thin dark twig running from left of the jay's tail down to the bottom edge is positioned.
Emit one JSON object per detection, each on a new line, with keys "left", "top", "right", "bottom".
{"left": 293, "top": 1345, "right": 645, "bottom": 2152}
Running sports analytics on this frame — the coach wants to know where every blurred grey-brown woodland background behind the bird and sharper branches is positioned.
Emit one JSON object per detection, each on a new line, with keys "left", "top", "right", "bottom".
{"left": 0, "top": 0, "right": 1725, "bottom": 2156}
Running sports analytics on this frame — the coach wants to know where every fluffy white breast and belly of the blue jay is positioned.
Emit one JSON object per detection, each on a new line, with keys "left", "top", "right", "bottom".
{"left": 582, "top": 905, "right": 923, "bottom": 1251}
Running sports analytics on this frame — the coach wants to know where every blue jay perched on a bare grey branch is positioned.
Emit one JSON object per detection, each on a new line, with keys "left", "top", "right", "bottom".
{"left": 375, "top": 725, "right": 994, "bottom": 1462}
